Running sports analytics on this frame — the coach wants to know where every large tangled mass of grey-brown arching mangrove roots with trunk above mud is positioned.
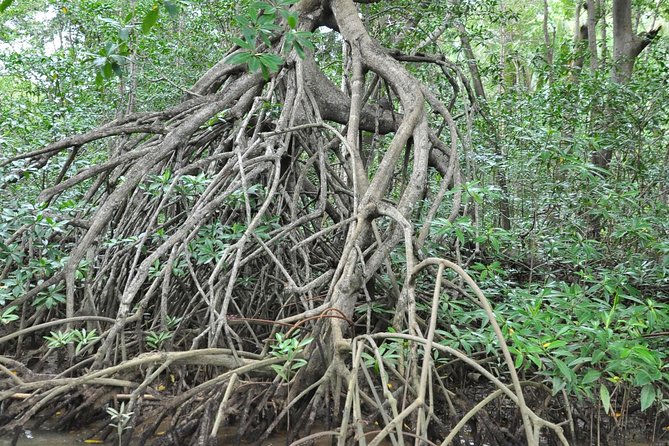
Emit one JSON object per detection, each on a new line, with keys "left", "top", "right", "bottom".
{"left": 0, "top": 0, "right": 566, "bottom": 445}
